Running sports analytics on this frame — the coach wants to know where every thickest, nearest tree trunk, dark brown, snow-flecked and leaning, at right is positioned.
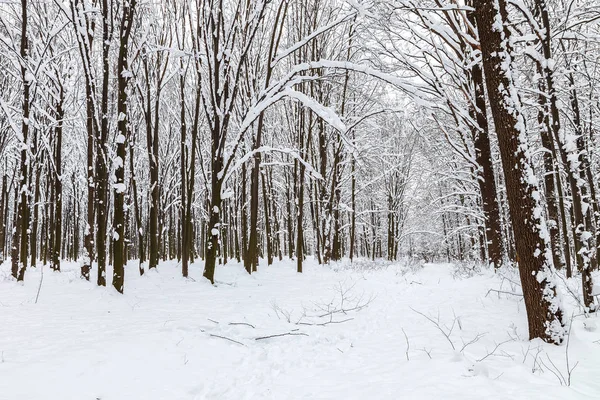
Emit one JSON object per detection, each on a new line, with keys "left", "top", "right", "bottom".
{"left": 474, "top": 0, "right": 565, "bottom": 343}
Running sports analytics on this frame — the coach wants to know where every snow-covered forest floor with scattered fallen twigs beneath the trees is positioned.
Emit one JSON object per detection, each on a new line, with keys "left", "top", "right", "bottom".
{"left": 0, "top": 259, "right": 600, "bottom": 400}
